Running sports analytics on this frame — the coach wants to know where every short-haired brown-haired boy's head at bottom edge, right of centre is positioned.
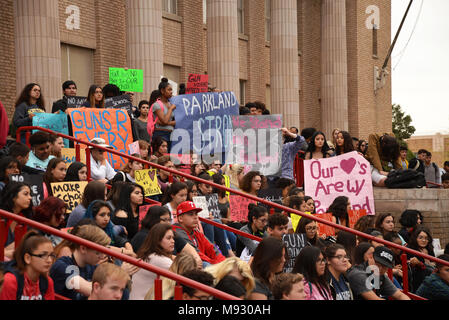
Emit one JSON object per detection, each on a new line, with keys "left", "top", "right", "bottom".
{"left": 272, "top": 273, "right": 306, "bottom": 300}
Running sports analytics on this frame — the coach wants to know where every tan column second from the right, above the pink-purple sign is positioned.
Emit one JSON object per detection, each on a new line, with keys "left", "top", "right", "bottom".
{"left": 271, "top": 0, "right": 299, "bottom": 126}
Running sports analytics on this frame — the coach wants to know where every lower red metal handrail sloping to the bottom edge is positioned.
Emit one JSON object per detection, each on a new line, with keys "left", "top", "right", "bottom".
{"left": 0, "top": 209, "right": 241, "bottom": 300}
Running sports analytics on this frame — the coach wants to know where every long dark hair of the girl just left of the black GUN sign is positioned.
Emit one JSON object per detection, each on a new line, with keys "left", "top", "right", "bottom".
{"left": 251, "top": 237, "right": 286, "bottom": 286}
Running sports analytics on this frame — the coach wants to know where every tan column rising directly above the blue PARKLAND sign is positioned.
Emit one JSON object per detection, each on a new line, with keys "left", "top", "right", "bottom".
{"left": 207, "top": 0, "right": 240, "bottom": 99}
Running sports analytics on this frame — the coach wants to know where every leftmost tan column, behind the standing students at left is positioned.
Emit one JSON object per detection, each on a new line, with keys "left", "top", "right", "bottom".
{"left": 14, "top": 0, "right": 62, "bottom": 111}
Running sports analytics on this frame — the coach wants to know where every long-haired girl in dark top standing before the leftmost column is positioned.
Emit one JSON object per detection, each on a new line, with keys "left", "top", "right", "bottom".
{"left": 12, "top": 83, "right": 45, "bottom": 143}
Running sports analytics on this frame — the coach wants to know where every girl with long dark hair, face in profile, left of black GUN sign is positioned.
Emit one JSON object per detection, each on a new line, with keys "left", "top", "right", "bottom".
{"left": 248, "top": 237, "right": 286, "bottom": 300}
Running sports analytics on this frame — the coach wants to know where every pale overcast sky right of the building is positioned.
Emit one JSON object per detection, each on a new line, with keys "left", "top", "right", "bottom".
{"left": 391, "top": 0, "right": 449, "bottom": 136}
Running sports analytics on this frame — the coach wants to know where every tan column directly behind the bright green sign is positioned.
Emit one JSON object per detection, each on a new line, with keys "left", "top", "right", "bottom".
{"left": 126, "top": 0, "right": 163, "bottom": 102}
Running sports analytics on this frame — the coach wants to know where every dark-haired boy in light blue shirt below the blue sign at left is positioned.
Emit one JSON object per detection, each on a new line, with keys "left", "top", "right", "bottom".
{"left": 26, "top": 131, "right": 55, "bottom": 172}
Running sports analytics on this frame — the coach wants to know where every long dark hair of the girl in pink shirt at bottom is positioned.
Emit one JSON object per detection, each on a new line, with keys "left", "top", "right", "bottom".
{"left": 292, "top": 246, "right": 329, "bottom": 289}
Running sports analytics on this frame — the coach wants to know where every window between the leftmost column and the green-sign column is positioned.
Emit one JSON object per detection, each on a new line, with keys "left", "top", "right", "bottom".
{"left": 61, "top": 43, "right": 94, "bottom": 97}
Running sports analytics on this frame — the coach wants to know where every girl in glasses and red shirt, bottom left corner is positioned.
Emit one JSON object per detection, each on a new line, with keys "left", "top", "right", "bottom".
{"left": 0, "top": 230, "right": 55, "bottom": 300}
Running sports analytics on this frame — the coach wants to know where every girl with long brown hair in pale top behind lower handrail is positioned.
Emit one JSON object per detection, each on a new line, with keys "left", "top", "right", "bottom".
{"left": 130, "top": 223, "right": 175, "bottom": 300}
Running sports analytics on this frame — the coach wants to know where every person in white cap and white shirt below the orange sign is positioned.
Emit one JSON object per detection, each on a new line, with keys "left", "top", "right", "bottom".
{"left": 89, "top": 138, "right": 115, "bottom": 183}
